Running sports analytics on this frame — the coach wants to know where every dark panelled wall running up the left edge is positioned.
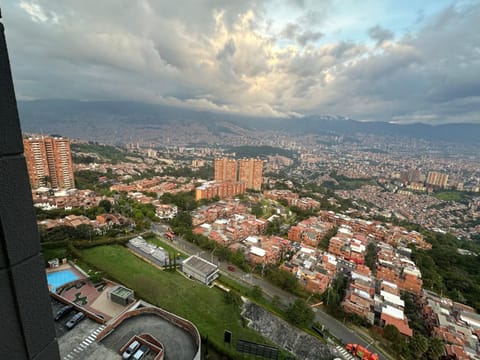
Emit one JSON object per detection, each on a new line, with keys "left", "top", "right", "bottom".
{"left": 0, "top": 12, "right": 60, "bottom": 360}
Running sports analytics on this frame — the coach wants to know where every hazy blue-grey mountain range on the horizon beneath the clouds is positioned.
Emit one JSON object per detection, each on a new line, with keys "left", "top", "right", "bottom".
{"left": 18, "top": 100, "right": 480, "bottom": 144}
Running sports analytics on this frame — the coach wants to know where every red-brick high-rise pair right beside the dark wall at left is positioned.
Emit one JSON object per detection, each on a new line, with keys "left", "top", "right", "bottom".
{"left": 23, "top": 136, "right": 75, "bottom": 189}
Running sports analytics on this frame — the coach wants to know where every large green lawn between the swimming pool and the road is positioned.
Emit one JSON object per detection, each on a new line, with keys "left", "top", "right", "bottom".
{"left": 81, "top": 245, "right": 266, "bottom": 359}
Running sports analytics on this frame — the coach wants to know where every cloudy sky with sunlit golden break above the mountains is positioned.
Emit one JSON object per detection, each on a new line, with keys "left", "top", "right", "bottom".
{"left": 2, "top": 0, "right": 480, "bottom": 124}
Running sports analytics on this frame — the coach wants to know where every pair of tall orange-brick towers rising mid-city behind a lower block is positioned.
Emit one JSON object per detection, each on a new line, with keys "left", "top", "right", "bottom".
{"left": 214, "top": 158, "right": 263, "bottom": 191}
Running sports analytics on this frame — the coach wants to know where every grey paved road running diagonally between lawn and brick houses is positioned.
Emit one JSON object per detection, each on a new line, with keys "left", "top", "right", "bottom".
{"left": 152, "top": 224, "right": 388, "bottom": 360}
